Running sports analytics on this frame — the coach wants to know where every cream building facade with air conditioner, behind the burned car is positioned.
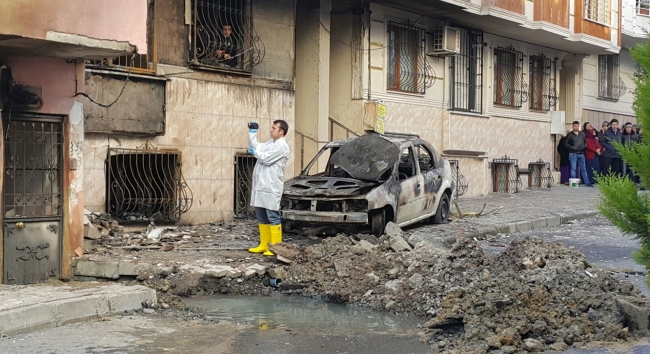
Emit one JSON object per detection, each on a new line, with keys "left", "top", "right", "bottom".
{"left": 295, "top": 0, "right": 620, "bottom": 196}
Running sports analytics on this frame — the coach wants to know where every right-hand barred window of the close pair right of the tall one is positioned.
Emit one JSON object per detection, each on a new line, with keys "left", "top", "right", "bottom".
{"left": 528, "top": 54, "right": 558, "bottom": 111}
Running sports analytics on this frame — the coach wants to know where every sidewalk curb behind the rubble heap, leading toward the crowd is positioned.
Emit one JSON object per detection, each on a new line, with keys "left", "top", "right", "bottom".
{"left": 470, "top": 210, "right": 600, "bottom": 237}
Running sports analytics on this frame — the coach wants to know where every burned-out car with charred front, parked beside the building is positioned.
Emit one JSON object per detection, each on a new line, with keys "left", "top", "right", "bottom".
{"left": 281, "top": 133, "right": 454, "bottom": 235}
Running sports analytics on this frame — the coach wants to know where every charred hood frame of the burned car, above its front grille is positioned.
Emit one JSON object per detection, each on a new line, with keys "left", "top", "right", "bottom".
{"left": 284, "top": 176, "right": 379, "bottom": 197}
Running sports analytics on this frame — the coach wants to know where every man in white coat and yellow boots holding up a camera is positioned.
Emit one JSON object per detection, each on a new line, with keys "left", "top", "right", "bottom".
{"left": 248, "top": 120, "right": 289, "bottom": 256}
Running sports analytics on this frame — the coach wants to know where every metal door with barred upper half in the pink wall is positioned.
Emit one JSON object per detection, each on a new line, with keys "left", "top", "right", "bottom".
{"left": 2, "top": 116, "right": 63, "bottom": 284}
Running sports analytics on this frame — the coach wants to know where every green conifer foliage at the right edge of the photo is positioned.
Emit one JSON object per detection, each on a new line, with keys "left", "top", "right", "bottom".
{"left": 598, "top": 42, "right": 650, "bottom": 269}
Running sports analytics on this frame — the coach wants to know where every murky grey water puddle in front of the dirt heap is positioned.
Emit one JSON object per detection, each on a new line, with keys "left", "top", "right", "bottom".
{"left": 183, "top": 294, "right": 425, "bottom": 335}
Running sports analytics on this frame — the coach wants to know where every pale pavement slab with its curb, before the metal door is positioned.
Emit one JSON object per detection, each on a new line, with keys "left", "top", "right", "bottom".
{"left": 0, "top": 284, "right": 157, "bottom": 335}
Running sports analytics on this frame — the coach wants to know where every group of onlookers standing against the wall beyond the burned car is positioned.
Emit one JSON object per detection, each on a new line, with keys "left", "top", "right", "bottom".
{"left": 557, "top": 119, "right": 643, "bottom": 186}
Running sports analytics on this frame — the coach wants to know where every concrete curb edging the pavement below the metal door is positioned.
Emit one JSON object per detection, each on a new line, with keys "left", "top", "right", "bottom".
{"left": 0, "top": 285, "right": 157, "bottom": 336}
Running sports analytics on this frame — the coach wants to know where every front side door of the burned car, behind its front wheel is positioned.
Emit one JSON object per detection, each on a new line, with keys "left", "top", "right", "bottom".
{"left": 396, "top": 145, "right": 425, "bottom": 224}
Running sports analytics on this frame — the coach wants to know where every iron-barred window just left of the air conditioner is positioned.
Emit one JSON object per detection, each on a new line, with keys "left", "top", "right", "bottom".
{"left": 388, "top": 21, "right": 435, "bottom": 94}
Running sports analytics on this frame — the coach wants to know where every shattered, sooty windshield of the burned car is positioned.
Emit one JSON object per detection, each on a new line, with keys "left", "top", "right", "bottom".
{"left": 330, "top": 134, "right": 400, "bottom": 181}
